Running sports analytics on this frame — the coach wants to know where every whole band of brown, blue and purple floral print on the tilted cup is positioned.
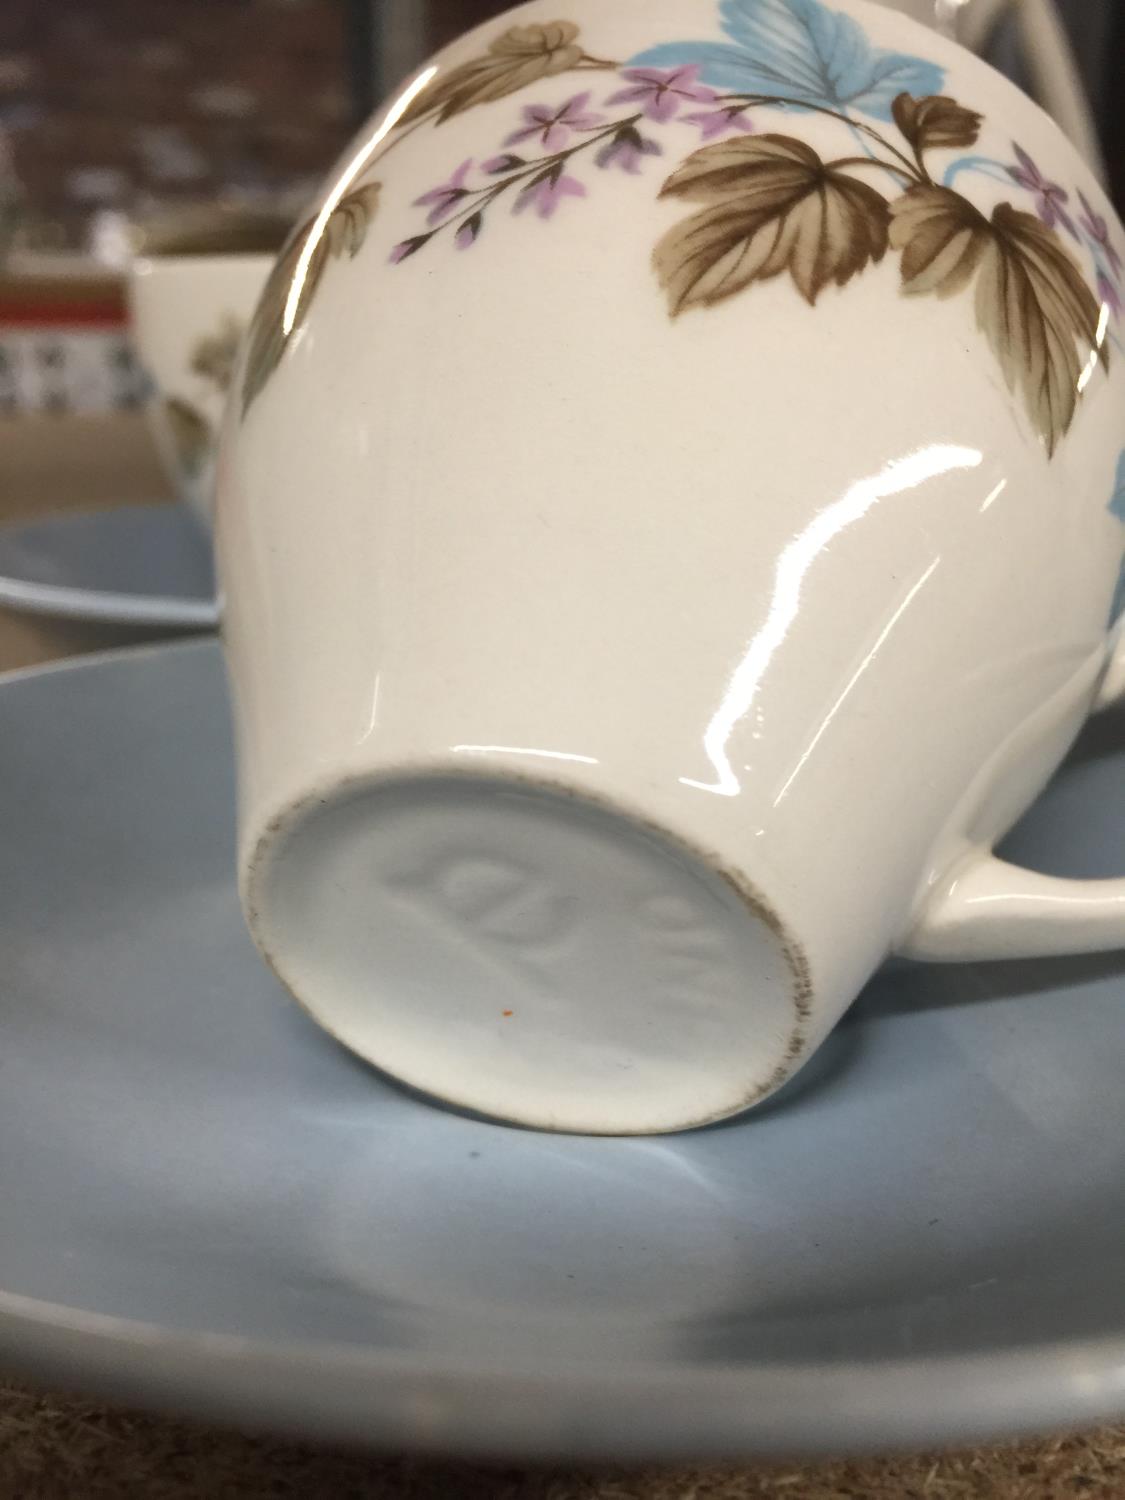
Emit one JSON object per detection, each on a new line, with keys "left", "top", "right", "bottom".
{"left": 243, "top": 0, "right": 1125, "bottom": 456}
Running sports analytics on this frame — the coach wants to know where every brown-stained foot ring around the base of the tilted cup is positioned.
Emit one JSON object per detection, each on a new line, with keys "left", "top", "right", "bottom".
{"left": 240, "top": 765, "right": 813, "bottom": 1137}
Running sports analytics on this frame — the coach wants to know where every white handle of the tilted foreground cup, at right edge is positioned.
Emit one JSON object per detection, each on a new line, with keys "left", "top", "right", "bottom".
{"left": 897, "top": 624, "right": 1125, "bottom": 962}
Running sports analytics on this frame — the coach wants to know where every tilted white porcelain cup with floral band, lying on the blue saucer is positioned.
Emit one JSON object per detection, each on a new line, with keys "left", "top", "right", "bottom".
{"left": 219, "top": 0, "right": 1125, "bottom": 1133}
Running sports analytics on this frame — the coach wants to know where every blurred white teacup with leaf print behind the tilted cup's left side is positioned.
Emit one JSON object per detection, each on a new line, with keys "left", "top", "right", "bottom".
{"left": 129, "top": 204, "right": 288, "bottom": 524}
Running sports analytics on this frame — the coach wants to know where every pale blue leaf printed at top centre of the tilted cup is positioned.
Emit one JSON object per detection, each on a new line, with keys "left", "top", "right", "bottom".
{"left": 630, "top": 0, "right": 945, "bottom": 120}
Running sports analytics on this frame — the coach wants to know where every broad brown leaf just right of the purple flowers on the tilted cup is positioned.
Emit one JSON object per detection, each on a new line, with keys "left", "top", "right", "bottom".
{"left": 653, "top": 135, "right": 890, "bottom": 317}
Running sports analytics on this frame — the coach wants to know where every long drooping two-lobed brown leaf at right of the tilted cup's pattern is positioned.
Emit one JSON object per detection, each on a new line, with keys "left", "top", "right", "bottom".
{"left": 891, "top": 188, "right": 1109, "bottom": 456}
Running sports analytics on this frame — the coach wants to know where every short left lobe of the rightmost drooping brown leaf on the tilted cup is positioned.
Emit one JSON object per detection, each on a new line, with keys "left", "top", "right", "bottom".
{"left": 891, "top": 188, "right": 992, "bottom": 297}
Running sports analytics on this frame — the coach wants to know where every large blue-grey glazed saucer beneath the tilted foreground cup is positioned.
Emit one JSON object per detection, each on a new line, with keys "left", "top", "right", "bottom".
{"left": 0, "top": 642, "right": 1125, "bottom": 1460}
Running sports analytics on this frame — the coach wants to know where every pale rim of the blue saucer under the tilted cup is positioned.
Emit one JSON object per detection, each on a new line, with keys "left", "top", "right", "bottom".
{"left": 0, "top": 636, "right": 1125, "bottom": 1463}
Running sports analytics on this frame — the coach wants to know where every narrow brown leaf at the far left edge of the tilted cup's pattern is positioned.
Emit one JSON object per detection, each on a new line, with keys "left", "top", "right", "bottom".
{"left": 242, "top": 183, "right": 380, "bottom": 416}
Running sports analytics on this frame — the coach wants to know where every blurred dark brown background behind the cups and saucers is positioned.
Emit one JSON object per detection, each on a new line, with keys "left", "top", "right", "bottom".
{"left": 0, "top": 0, "right": 1125, "bottom": 669}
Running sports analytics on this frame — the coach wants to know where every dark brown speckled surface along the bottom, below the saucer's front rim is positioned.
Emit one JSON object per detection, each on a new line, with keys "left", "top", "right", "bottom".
{"left": 0, "top": 1383, "right": 1125, "bottom": 1500}
